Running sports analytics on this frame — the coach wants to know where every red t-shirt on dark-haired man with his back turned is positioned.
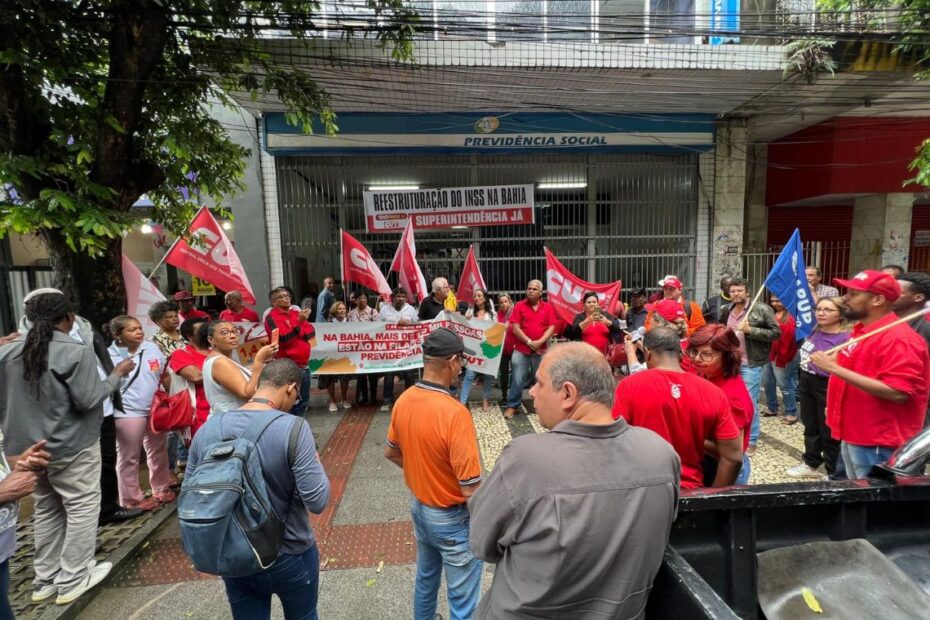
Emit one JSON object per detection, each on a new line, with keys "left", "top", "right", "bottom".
{"left": 613, "top": 368, "right": 739, "bottom": 489}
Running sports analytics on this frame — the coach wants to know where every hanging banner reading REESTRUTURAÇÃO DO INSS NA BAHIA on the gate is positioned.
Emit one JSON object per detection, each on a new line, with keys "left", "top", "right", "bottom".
{"left": 362, "top": 185, "right": 535, "bottom": 233}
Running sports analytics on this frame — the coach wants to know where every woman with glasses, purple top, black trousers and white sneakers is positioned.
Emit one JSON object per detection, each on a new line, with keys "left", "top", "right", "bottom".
{"left": 785, "top": 297, "right": 850, "bottom": 480}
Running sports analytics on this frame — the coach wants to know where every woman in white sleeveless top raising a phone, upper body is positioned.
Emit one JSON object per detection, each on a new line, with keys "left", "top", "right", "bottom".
{"left": 200, "top": 321, "right": 278, "bottom": 416}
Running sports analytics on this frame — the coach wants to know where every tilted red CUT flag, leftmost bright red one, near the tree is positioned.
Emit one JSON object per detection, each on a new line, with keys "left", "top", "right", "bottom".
{"left": 165, "top": 207, "right": 255, "bottom": 305}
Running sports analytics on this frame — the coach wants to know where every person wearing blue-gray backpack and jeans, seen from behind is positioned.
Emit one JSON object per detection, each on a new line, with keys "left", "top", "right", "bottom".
{"left": 178, "top": 359, "right": 330, "bottom": 620}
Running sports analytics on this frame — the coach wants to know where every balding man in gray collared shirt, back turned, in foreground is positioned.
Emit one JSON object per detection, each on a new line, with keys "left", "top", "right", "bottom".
{"left": 469, "top": 343, "right": 681, "bottom": 618}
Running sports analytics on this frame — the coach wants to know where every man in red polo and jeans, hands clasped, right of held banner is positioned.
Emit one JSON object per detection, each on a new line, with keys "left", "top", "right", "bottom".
{"left": 504, "top": 280, "right": 557, "bottom": 419}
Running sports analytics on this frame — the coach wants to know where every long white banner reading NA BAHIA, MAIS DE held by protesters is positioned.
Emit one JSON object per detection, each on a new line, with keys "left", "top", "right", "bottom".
{"left": 309, "top": 312, "right": 507, "bottom": 376}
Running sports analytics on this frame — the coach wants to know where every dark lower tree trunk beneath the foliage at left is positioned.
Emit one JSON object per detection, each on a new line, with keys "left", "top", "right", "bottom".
{"left": 42, "top": 230, "right": 126, "bottom": 330}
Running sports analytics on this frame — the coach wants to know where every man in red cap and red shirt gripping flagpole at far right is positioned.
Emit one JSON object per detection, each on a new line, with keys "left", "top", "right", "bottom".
{"left": 811, "top": 270, "right": 930, "bottom": 478}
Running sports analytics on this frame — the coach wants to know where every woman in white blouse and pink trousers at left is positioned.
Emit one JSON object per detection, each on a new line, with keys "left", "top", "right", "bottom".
{"left": 107, "top": 315, "right": 175, "bottom": 510}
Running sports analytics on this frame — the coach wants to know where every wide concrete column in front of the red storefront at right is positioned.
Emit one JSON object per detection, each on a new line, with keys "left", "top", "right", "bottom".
{"left": 849, "top": 193, "right": 914, "bottom": 275}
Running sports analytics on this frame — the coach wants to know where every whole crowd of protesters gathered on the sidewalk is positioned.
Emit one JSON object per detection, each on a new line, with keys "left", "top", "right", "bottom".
{"left": 0, "top": 234, "right": 930, "bottom": 619}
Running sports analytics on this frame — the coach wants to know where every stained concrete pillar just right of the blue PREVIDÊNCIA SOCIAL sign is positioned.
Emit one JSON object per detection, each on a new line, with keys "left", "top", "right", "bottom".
{"left": 710, "top": 120, "right": 747, "bottom": 282}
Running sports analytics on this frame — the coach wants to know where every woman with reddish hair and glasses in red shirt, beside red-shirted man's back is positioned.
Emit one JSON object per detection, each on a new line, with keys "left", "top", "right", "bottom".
{"left": 687, "top": 323, "right": 753, "bottom": 484}
